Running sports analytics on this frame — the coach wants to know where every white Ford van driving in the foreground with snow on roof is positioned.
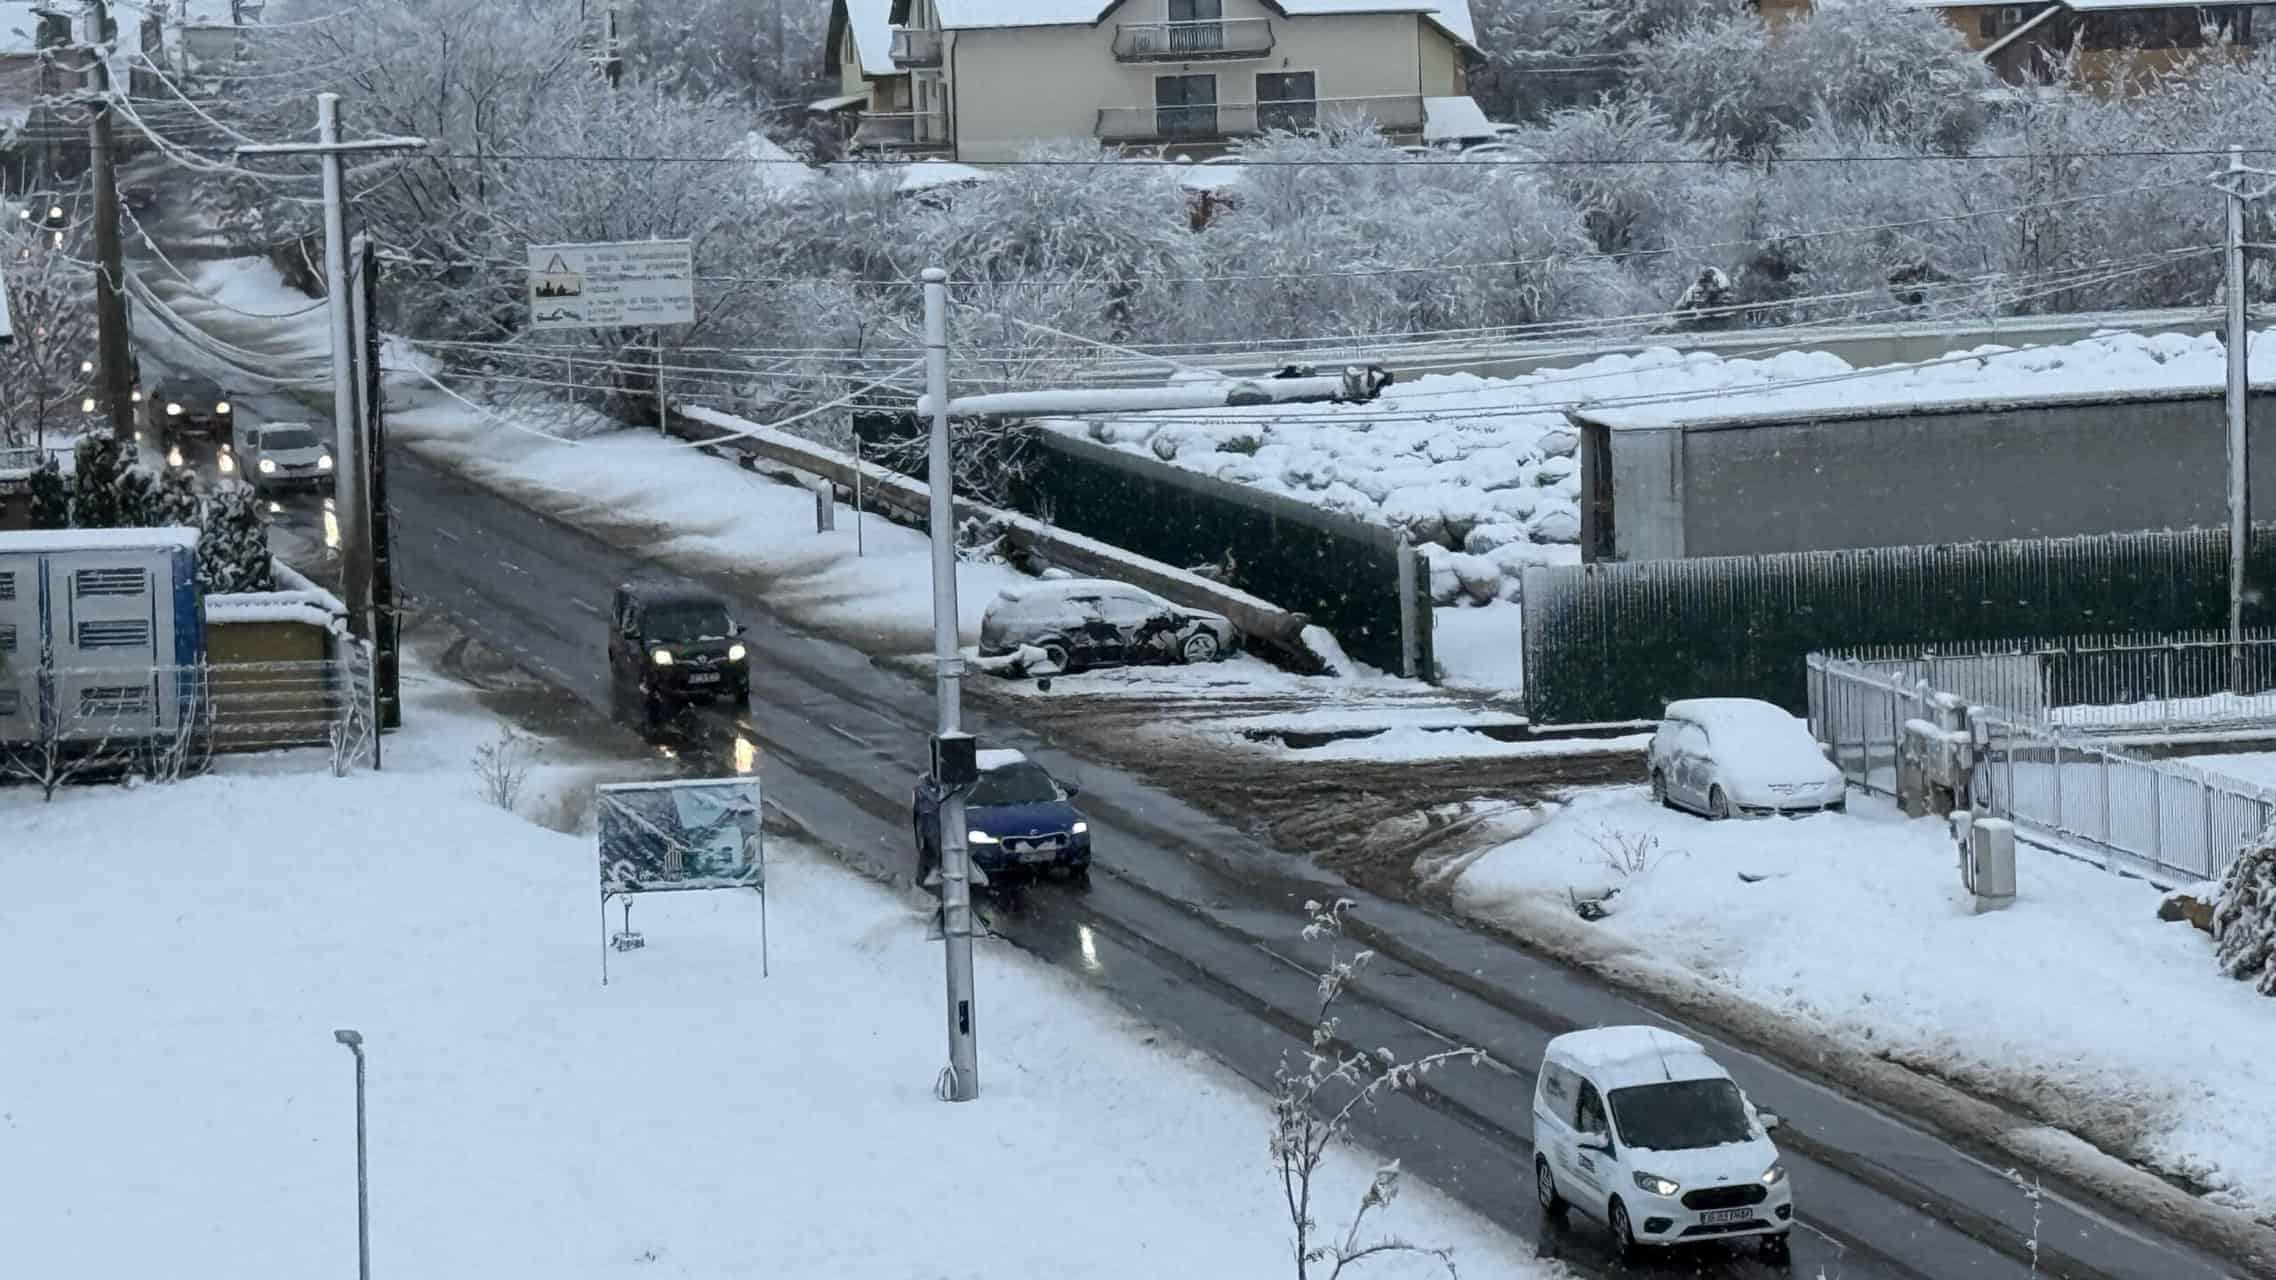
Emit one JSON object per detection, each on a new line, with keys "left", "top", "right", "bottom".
{"left": 1534, "top": 1027, "right": 1793, "bottom": 1260}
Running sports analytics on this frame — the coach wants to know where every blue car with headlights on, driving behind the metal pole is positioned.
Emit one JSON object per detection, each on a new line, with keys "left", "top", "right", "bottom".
{"left": 910, "top": 749, "right": 1090, "bottom": 884}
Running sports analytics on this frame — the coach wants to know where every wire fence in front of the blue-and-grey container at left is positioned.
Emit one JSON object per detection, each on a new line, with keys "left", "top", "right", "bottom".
{"left": 0, "top": 645, "right": 378, "bottom": 788}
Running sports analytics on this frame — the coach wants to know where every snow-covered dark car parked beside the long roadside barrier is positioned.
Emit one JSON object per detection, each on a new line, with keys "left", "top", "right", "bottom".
{"left": 981, "top": 579, "right": 1240, "bottom": 672}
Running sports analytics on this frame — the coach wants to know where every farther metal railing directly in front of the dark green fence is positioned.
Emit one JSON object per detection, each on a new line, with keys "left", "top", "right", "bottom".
{"left": 1830, "top": 629, "right": 2276, "bottom": 733}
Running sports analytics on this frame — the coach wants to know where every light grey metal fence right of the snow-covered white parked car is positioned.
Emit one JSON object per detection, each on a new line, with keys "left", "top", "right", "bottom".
{"left": 1809, "top": 654, "right": 2276, "bottom": 886}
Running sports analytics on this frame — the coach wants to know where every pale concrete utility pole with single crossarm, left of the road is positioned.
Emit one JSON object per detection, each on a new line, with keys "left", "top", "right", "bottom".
{"left": 237, "top": 93, "right": 428, "bottom": 751}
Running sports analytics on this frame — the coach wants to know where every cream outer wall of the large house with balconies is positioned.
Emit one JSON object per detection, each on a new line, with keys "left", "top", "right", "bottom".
{"left": 942, "top": 0, "right": 1461, "bottom": 164}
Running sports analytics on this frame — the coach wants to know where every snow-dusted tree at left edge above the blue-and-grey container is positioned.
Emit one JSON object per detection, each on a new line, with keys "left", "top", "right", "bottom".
{"left": 0, "top": 219, "right": 96, "bottom": 449}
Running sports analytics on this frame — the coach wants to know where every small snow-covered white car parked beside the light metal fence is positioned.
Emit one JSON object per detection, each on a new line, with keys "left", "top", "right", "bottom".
{"left": 1646, "top": 697, "right": 1848, "bottom": 818}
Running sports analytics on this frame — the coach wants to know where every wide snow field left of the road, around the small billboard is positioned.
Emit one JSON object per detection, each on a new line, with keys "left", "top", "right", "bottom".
{"left": 0, "top": 660, "right": 1550, "bottom": 1280}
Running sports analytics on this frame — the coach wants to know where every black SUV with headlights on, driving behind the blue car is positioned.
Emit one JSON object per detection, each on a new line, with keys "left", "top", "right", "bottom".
{"left": 608, "top": 583, "right": 751, "bottom": 717}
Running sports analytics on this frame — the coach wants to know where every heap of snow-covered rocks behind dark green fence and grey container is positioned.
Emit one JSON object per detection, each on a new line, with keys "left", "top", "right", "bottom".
{"left": 1052, "top": 333, "right": 2276, "bottom": 604}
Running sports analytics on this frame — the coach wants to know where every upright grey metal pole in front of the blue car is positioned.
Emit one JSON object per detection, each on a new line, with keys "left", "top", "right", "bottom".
{"left": 924, "top": 266, "right": 981, "bottom": 1102}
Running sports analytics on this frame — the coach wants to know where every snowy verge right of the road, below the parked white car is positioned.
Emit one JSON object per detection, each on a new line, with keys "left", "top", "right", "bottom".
{"left": 1454, "top": 788, "right": 2276, "bottom": 1216}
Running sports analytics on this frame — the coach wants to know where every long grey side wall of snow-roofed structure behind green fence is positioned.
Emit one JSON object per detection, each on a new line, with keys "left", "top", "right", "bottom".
{"left": 1573, "top": 378, "right": 2276, "bottom": 560}
